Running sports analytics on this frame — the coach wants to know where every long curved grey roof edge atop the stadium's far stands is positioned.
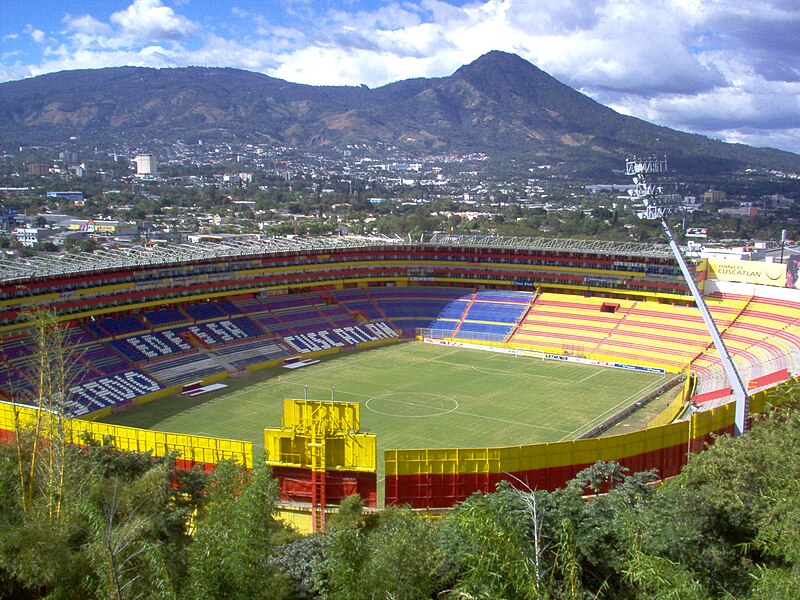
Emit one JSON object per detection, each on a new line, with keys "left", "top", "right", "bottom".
{"left": 0, "top": 234, "right": 672, "bottom": 281}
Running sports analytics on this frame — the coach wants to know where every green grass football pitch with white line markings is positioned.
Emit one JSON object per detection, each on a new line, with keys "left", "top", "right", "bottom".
{"left": 103, "top": 342, "right": 670, "bottom": 473}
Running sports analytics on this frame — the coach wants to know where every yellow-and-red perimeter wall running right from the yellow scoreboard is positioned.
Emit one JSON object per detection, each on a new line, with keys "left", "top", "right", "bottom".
{"left": 384, "top": 379, "right": 798, "bottom": 509}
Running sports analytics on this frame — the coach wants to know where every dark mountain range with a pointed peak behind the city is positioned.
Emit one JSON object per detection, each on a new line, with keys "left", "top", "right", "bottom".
{"left": 0, "top": 51, "right": 800, "bottom": 173}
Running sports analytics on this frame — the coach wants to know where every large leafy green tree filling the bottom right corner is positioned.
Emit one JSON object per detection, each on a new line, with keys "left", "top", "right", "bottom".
{"left": 629, "top": 396, "right": 800, "bottom": 597}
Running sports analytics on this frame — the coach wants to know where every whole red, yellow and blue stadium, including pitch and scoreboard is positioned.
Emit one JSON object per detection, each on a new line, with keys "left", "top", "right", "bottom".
{"left": 0, "top": 234, "right": 800, "bottom": 528}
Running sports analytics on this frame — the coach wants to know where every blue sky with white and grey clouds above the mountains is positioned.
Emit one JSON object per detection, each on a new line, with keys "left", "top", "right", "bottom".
{"left": 0, "top": 0, "right": 800, "bottom": 153}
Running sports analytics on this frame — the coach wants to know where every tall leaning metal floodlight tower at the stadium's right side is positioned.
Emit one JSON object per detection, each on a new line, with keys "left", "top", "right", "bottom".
{"left": 625, "top": 157, "right": 748, "bottom": 436}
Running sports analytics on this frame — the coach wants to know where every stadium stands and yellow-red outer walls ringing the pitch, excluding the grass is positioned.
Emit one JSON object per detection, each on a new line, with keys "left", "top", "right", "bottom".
{"left": 0, "top": 235, "right": 800, "bottom": 508}
